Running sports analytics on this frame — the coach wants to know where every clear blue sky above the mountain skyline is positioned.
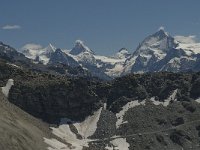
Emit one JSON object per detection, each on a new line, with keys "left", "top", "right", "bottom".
{"left": 0, "top": 0, "right": 200, "bottom": 55}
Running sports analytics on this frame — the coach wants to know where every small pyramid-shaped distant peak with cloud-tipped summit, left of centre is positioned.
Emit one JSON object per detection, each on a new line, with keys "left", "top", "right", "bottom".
{"left": 70, "top": 40, "right": 94, "bottom": 55}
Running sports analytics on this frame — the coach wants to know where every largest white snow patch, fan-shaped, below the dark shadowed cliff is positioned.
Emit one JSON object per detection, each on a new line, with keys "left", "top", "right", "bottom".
{"left": 44, "top": 108, "right": 102, "bottom": 150}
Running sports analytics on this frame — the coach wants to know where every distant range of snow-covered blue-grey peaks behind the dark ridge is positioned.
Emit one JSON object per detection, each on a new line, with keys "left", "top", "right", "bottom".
{"left": 19, "top": 29, "right": 200, "bottom": 79}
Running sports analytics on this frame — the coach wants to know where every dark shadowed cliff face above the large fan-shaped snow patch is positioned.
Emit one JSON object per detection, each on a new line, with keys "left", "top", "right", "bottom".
{"left": 9, "top": 78, "right": 100, "bottom": 123}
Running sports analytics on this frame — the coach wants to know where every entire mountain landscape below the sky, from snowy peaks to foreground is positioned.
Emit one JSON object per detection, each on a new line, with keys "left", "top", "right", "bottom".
{"left": 0, "top": 29, "right": 200, "bottom": 150}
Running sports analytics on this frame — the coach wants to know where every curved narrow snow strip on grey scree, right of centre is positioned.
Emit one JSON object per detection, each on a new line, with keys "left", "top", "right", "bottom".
{"left": 116, "top": 100, "right": 145, "bottom": 128}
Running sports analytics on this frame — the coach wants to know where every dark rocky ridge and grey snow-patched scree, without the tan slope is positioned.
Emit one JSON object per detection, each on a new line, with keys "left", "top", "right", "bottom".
{"left": 0, "top": 59, "right": 200, "bottom": 150}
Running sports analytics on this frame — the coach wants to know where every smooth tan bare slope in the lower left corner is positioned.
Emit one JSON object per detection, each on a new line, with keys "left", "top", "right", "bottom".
{"left": 0, "top": 85, "right": 54, "bottom": 150}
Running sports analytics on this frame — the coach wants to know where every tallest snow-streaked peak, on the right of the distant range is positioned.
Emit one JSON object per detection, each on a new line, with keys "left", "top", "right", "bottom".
{"left": 124, "top": 28, "right": 177, "bottom": 73}
